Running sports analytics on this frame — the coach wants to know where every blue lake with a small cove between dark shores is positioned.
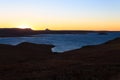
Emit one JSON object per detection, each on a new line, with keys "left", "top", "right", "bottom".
{"left": 0, "top": 32, "right": 120, "bottom": 52}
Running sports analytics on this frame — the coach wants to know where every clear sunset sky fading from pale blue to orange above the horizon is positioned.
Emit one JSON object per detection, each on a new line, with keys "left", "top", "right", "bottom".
{"left": 0, "top": 0, "right": 120, "bottom": 31}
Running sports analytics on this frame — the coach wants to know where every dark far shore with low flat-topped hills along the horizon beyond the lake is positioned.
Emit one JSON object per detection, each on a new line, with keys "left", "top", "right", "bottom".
{"left": 0, "top": 28, "right": 119, "bottom": 37}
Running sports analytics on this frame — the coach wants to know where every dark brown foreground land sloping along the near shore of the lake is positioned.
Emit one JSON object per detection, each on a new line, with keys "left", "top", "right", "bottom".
{"left": 0, "top": 38, "right": 120, "bottom": 80}
